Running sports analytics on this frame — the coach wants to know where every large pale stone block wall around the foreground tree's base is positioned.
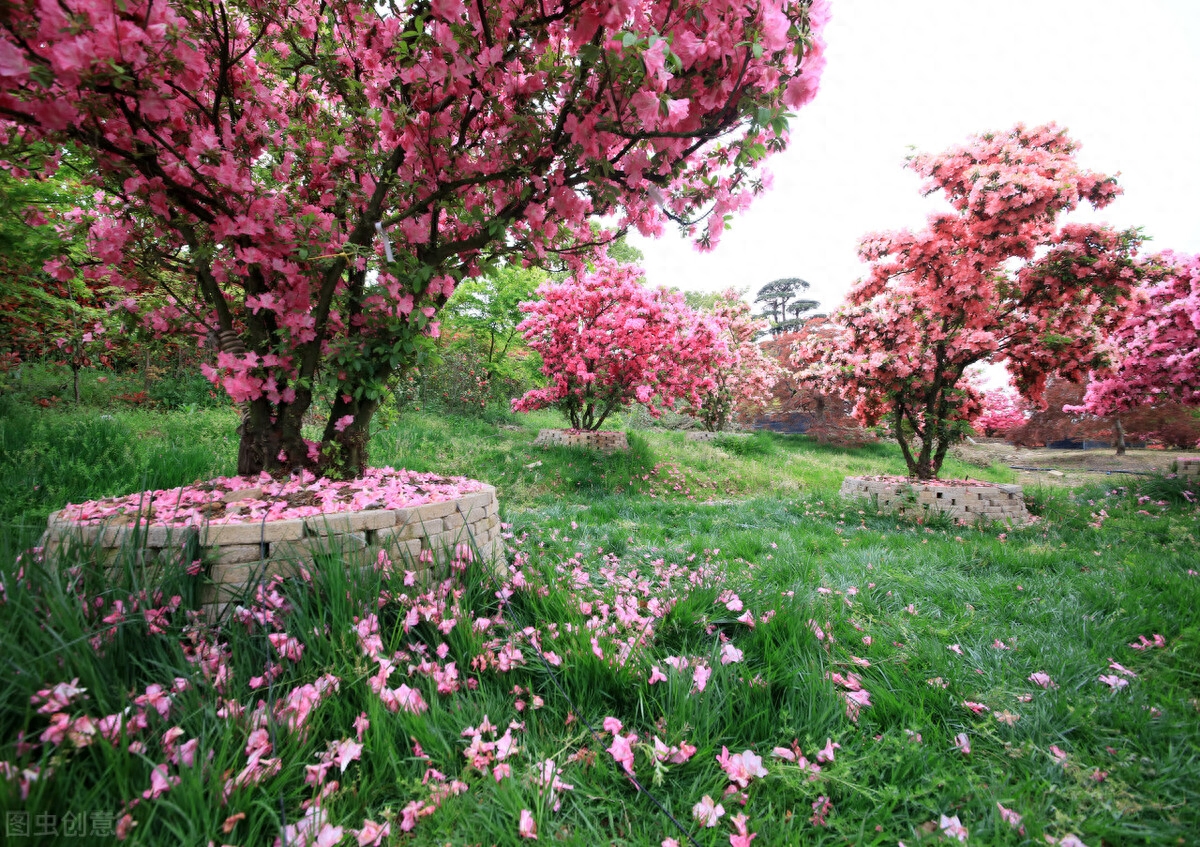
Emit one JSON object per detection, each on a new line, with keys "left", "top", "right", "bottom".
{"left": 42, "top": 472, "right": 504, "bottom": 615}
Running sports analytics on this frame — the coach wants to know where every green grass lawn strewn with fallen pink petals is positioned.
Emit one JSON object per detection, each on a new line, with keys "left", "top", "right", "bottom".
{"left": 0, "top": 393, "right": 1200, "bottom": 847}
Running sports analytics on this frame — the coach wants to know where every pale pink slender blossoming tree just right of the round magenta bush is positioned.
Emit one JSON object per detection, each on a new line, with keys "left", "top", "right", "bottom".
{"left": 686, "top": 289, "right": 782, "bottom": 432}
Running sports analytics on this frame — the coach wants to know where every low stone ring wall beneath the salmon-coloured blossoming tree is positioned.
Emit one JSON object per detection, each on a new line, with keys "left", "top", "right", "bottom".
{"left": 841, "top": 476, "right": 1033, "bottom": 523}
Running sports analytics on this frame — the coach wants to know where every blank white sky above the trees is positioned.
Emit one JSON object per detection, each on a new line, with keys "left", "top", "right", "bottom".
{"left": 630, "top": 0, "right": 1200, "bottom": 311}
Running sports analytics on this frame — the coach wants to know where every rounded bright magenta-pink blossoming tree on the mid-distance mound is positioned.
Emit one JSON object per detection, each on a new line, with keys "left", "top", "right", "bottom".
{"left": 512, "top": 259, "right": 730, "bottom": 429}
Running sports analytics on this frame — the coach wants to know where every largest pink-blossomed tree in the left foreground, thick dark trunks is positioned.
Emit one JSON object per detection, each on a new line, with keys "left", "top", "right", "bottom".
{"left": 0, "top": 0, "right": 827, "bottom": 474}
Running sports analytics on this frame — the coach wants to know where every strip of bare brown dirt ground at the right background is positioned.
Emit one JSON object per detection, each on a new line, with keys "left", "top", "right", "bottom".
{"left": 950, "top": 439, "right": 1196, "bottom": 488}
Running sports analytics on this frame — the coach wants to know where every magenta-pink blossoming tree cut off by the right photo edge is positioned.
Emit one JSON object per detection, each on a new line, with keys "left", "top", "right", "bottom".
{"left": 1068, "top": 252, "right": 1200, "bottom": 416}
